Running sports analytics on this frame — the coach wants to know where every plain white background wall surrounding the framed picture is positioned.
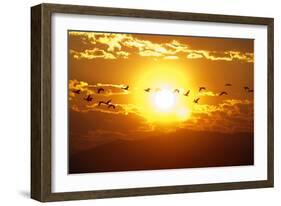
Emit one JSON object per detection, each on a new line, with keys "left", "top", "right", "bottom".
{"left": 0, "top": 0, "right": 281, "bottom": 206}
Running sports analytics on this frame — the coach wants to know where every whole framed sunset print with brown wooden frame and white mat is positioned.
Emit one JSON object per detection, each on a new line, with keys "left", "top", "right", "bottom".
{"left": 31, "top": 4, "right": 274, "bottom": 202}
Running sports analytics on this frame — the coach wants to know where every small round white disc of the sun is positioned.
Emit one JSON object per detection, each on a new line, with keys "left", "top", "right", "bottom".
{"left": 153, "top": 89, "right": 176, "bottom": 110}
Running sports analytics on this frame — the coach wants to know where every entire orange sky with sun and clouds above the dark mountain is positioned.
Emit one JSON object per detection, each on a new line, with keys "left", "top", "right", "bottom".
{"left": 68, "top": 31, "right": 254, "bottom": 172}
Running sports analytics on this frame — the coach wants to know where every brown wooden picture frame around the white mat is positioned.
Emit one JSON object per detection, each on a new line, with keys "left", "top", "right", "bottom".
{"left": 31, "top": 4, "right": 274, "bottom": 202}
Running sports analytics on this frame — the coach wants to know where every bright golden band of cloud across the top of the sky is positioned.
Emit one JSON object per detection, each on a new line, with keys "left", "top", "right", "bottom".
{"left": 69, "top": 32, "right": 254, "bottom": 63}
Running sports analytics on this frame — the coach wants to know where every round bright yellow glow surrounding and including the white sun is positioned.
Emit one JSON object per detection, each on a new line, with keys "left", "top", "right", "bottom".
{"left": 131, "top": 63, "right": 193, "bottom": 124}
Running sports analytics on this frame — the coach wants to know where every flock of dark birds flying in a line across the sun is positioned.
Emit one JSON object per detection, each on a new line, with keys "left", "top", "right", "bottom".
{"left": 72, "top": 83, "right": 254, "bottom": 109}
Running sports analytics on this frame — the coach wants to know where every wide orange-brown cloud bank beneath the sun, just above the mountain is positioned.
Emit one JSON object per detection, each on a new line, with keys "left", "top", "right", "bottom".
{"left": 69, "top": 99, "right": 253, "bottom": 153}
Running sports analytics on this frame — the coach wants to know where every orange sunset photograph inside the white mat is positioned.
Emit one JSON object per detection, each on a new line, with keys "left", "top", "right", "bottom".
{"left": 66, "top": 30, "right": 254, "bottom": 174}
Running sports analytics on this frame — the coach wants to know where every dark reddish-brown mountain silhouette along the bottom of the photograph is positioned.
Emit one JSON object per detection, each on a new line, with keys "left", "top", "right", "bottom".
{"left": 69, "top": 131, "right": 254, "bottom": 174}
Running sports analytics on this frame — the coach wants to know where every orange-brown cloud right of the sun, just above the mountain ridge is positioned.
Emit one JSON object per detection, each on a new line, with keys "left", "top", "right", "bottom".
{"left": 188, "top": 99, "right": 254, "bottom": 133}
